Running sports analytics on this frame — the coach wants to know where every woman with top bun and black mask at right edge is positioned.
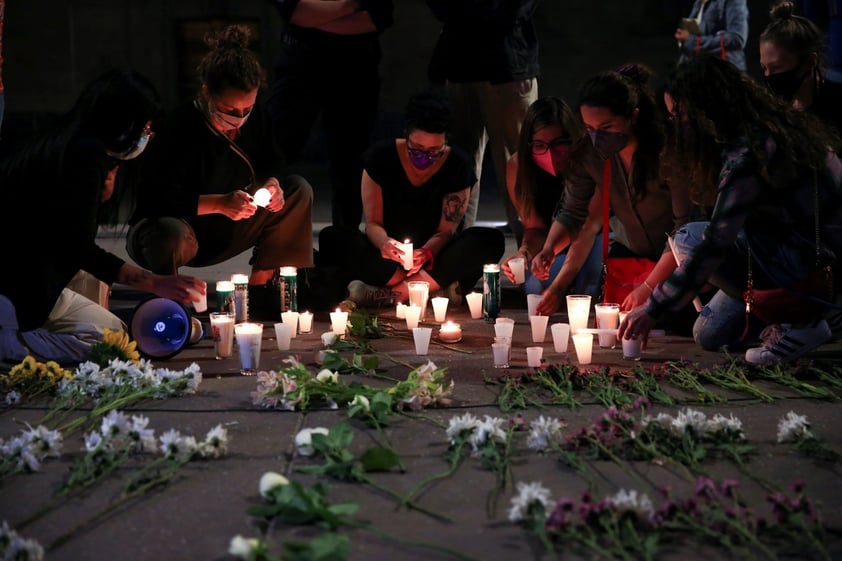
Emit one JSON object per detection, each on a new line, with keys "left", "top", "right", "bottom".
{"left": 760, "top": 2, "right": 842, "bottom": 133}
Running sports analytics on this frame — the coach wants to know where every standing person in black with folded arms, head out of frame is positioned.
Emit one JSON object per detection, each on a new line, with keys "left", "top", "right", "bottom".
{"left": 267, "top": 0, "right": 393, "bottom": 227}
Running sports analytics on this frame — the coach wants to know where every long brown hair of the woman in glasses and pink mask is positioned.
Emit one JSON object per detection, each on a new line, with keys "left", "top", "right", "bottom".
{"left": 515, "top": 97, "right": 586, "bottom": 218}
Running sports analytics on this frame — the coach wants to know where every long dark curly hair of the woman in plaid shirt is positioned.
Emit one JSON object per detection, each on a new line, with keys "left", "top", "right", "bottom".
{"left": 664, "top": 56, "right": 839, "bottom": 205}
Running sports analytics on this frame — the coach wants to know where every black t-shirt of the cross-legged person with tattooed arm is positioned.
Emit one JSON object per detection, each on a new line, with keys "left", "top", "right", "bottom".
{"left": 363, "top": 139, "right": 477, "bottom": 242}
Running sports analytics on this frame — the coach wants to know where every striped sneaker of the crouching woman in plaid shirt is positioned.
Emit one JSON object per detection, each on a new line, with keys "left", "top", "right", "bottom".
{"left": 746, "top": 319, "right": 831, "bottom": 364}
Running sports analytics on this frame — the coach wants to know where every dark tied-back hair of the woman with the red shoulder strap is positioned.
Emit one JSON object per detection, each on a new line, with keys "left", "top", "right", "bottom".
{"left": 579, "top": 63, "right": 664, "bottom": 199}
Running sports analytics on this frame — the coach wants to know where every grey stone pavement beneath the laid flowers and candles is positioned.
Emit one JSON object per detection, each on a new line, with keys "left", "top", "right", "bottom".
{"left": 0, "top": 230, "right": 842, "bottom": 561}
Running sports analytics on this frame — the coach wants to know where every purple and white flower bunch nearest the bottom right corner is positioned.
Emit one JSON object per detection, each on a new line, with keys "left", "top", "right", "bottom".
{"left": 509, "top": 477, "right": 830, "bottom": 561}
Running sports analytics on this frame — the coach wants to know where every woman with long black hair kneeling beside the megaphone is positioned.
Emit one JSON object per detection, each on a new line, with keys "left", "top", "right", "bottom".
{"left": 0, "top": 69, "right": 206, "bottom": 365}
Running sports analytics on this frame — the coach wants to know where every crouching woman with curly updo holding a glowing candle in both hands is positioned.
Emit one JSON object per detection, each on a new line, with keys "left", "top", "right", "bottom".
{"left": 126, "top": 26, "right": 313, "bottom": 318}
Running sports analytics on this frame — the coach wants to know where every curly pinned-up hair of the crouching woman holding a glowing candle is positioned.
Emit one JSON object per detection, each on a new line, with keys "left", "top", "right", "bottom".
{"left": 196, "top": 25, "right": 266, "bottom": 96}
